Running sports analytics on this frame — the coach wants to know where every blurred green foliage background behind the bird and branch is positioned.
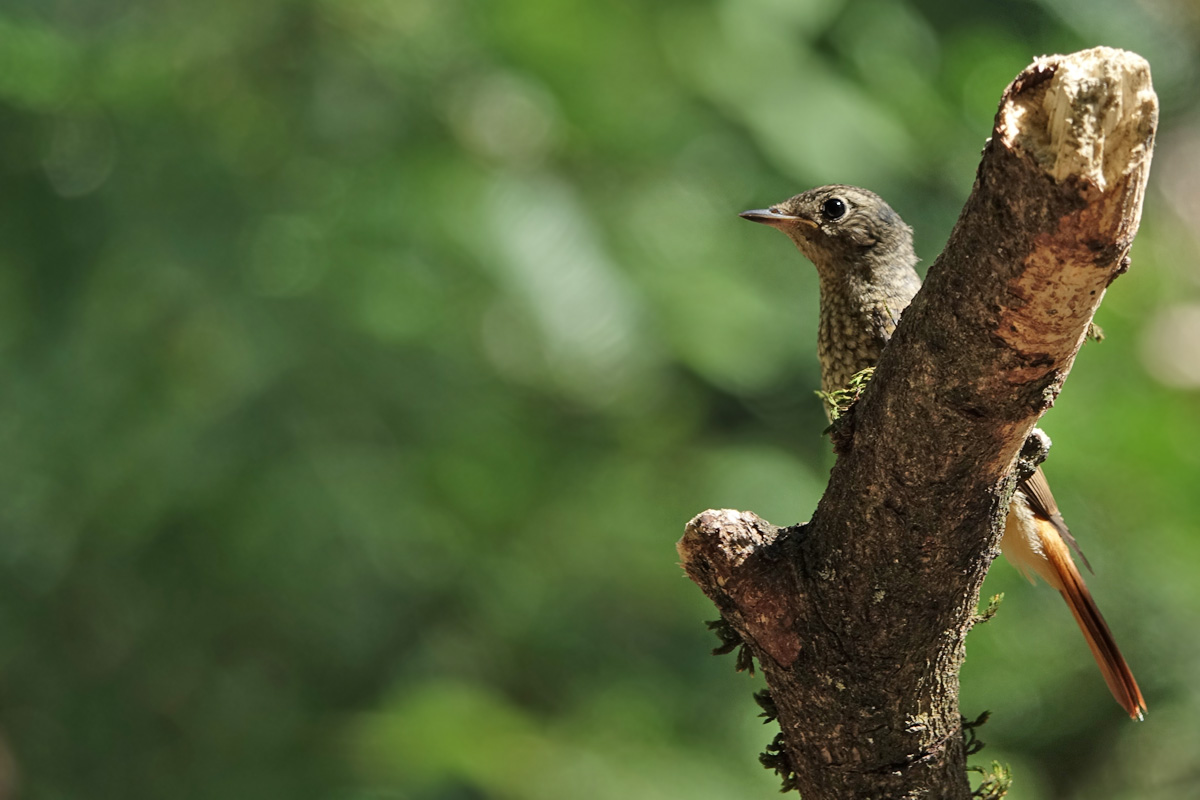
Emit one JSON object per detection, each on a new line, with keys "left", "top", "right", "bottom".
{"left": 0, "top": 0, "right": 1200, "bottom": 800}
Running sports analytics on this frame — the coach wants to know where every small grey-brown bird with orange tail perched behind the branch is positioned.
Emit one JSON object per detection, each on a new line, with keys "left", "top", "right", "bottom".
{"left": 739, "top": 185, "right": 1146, "bottom": 720}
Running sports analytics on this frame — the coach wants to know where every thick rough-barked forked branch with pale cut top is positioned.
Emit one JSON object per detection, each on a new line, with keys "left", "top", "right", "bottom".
{"left": 678, "top": 48, "right": 1158, "bottom": 800}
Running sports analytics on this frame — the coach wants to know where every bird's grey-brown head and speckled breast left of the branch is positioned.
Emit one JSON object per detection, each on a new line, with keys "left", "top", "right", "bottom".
{"left": 742, "top": 185, "right": 920, "bottom": 392}
